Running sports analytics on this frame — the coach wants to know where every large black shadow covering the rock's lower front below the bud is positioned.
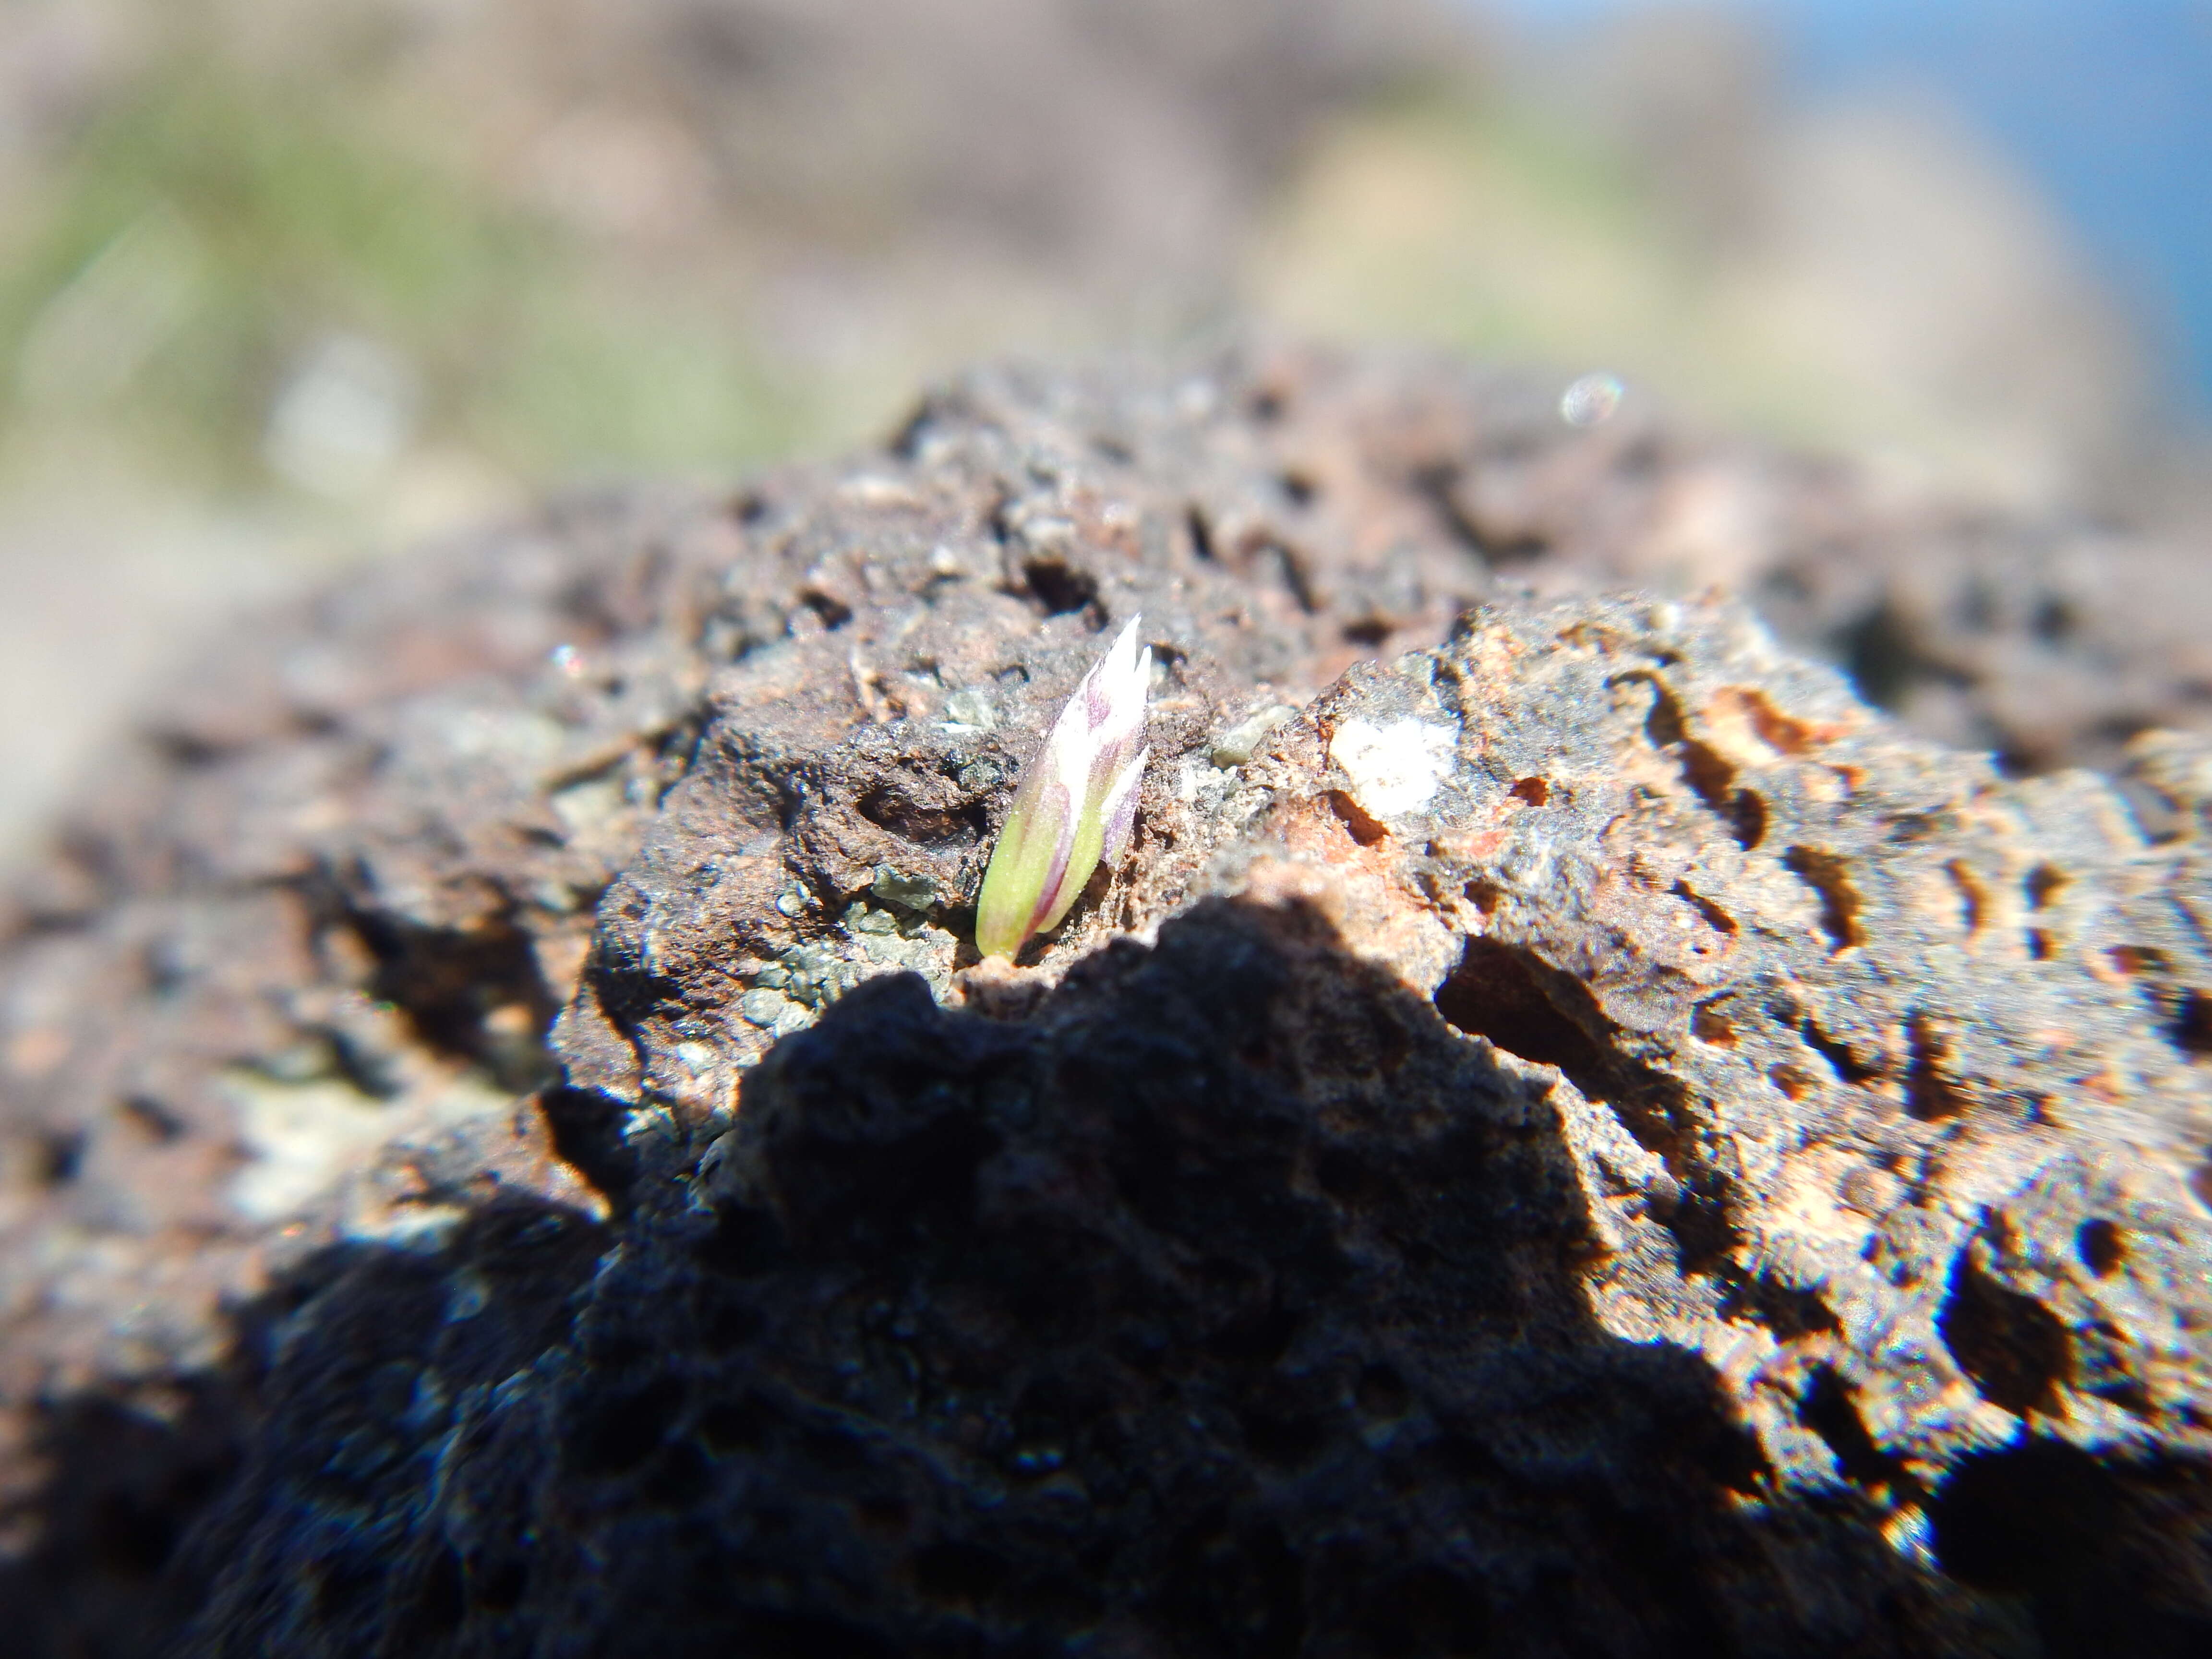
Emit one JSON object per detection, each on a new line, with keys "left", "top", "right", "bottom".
{"left": 17, "top": 900, "right": 2203, "bottom": 1659}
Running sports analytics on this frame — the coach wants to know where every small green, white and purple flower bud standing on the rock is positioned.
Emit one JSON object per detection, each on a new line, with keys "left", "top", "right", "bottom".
{"left": 975, "top": 617, "right": 1153, "bottom": 960}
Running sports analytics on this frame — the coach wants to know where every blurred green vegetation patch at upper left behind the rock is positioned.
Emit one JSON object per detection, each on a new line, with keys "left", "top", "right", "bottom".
{"left": 0, "top": 60, "right": 810, "bottom": 504}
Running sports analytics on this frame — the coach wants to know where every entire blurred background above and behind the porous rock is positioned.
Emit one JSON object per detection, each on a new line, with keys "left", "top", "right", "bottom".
{"left": 0, "top": 0, "right": 2212, "bottom": 861}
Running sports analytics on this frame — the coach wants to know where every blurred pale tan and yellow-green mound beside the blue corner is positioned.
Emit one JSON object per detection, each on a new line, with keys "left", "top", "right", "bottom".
{"left": 1248, "top": 84, "right": 2143, "bottom": 506}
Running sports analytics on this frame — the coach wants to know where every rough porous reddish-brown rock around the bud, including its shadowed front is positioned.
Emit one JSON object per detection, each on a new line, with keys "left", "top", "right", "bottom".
{"left": 0, "top": 354, "right": 2212, "bottom": 1655}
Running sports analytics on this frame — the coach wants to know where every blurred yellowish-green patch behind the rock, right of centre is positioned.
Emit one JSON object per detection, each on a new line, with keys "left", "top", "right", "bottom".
{"left": 1256, "top": 88, "right": 1867, "bottom": 462}
